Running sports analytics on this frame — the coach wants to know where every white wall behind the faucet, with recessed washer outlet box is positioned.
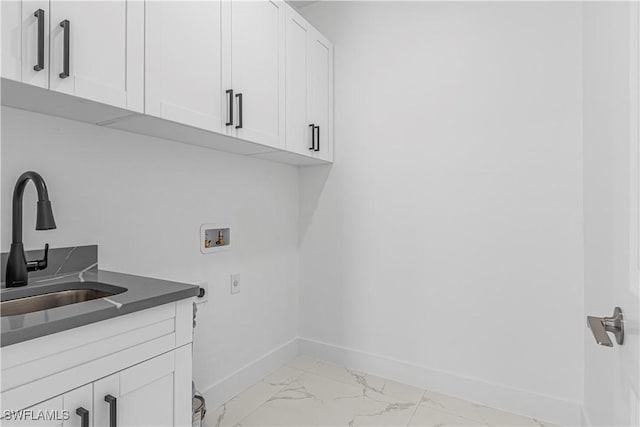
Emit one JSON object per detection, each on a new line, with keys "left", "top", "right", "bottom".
{"left": 0, "top": 107, "right": 299, "bottom": 405}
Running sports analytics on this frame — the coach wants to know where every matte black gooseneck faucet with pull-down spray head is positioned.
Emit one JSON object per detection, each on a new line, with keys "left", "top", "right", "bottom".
{"left": 6, "top": 171, "right": 56, "bottom": 288}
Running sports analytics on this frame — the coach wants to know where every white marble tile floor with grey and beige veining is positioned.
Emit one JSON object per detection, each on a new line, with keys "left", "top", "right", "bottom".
{"left": 205, "top": 356, "right": 550, "bottom": 427}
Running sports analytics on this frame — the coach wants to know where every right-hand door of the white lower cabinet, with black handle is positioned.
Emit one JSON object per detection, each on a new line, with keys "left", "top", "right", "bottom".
{"left": 93, "top": 348, "right": 191, "bottom": 427}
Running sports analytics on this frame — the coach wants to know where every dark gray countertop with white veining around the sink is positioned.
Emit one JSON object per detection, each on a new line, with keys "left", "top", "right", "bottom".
{"left": 0, "top": 269, "right": 198, "bottom": 347}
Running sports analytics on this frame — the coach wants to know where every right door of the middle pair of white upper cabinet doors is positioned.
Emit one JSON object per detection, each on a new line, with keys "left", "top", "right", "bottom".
{"left": 223, "top": 0, "right": 285, "bottom": 148}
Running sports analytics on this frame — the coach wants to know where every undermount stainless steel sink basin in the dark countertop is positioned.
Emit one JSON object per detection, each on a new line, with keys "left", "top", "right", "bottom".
{"left": 0, "top": 282, "right": 127, "bottom": 317}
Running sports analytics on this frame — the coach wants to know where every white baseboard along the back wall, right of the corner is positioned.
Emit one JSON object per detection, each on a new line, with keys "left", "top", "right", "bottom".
{"left": 299, "top": 338, "right": 582, "bottom": 426}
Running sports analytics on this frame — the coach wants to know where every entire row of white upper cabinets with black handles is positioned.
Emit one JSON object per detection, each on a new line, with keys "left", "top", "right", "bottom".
{"left": 0, "top": 0, "right": 333, "bottom": 165}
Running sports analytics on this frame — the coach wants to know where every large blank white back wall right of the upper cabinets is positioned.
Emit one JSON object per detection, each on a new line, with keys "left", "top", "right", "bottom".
{"left": 300, "top": 2, "right": 584, "bottom": 424}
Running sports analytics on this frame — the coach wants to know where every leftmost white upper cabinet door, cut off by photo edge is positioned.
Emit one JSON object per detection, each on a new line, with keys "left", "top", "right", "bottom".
{"left": 0, "top": 0, "right": 49, "bottom": 88}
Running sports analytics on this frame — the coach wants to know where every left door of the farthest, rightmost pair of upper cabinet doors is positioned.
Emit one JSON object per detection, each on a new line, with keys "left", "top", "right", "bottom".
{"left": 286, "top": 6, "right": 315, "bottom": 155}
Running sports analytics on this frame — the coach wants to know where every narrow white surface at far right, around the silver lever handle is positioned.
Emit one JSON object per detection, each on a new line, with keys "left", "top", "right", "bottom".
{"left": 583, "top": 2, "right": 631, "bottom": 426}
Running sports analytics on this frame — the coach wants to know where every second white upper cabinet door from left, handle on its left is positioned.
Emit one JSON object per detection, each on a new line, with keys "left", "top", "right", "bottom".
{"left": 49, "top": 0, "right": 144, "bottom": 112}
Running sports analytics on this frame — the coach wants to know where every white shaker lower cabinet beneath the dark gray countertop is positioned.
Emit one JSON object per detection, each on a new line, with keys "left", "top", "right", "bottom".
{"left": 0, "top": 299, "right": 193, "bottom": 427}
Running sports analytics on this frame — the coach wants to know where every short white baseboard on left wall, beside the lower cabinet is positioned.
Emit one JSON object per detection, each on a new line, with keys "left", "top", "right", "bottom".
{"left": 202, "top": 338, "right": 299, "bottom": 411}
